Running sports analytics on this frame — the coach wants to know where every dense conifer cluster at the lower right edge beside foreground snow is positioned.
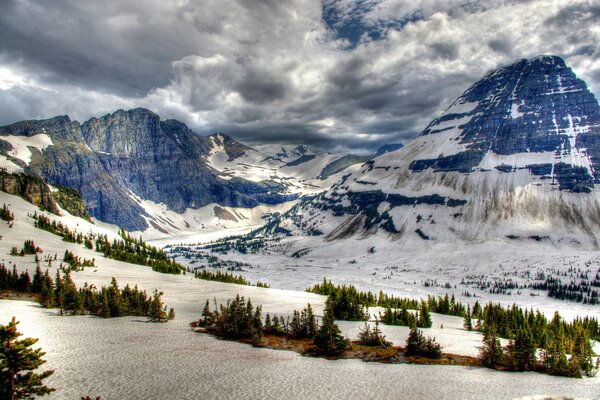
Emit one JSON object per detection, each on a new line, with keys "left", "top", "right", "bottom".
{"left": 474, "top": 303, "right": 600, "bottom": 377}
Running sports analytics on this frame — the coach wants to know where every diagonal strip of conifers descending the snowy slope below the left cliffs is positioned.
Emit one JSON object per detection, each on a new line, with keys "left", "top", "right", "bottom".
{"left": 31, "top": 212, "right": 185, "bottom": 274}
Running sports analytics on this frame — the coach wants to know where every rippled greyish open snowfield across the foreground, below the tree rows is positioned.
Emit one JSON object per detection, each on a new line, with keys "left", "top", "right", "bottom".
{"left": 0, "top": 304, "right": 600, "bottom": 400}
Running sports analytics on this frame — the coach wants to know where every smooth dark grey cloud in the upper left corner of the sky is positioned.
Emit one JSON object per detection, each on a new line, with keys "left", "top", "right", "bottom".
{"left": 0, "top": 0, "right": 191, "bottom": 96}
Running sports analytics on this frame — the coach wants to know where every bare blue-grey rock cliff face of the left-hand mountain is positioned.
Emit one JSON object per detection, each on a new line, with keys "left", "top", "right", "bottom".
{"left": 0, "top": 109, "right": 295, "bottom": 230}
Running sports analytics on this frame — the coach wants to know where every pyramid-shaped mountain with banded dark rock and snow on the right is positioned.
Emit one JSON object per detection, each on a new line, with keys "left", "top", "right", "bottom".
{"left": 267, "top": 56, "right": 600, "bottom": 248}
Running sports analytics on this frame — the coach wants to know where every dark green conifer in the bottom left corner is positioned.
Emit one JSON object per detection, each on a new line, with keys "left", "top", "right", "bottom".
{"left": 0, "top": 317, "right": 55, "bottom": 400}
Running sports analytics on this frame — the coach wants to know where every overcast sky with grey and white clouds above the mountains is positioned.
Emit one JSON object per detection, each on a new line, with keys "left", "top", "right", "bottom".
{"left": 0, "top": 0, "right": 600, "bottom": 151}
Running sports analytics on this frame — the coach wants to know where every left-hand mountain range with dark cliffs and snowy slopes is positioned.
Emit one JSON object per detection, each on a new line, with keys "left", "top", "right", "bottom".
{"left": 0, "top": 108, "right": 404, "bottom": 234}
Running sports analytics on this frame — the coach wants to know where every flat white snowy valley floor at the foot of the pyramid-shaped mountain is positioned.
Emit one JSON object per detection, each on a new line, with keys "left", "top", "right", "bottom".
{"left": 168, "top": 235, "right": 600, "bottom": 320}
